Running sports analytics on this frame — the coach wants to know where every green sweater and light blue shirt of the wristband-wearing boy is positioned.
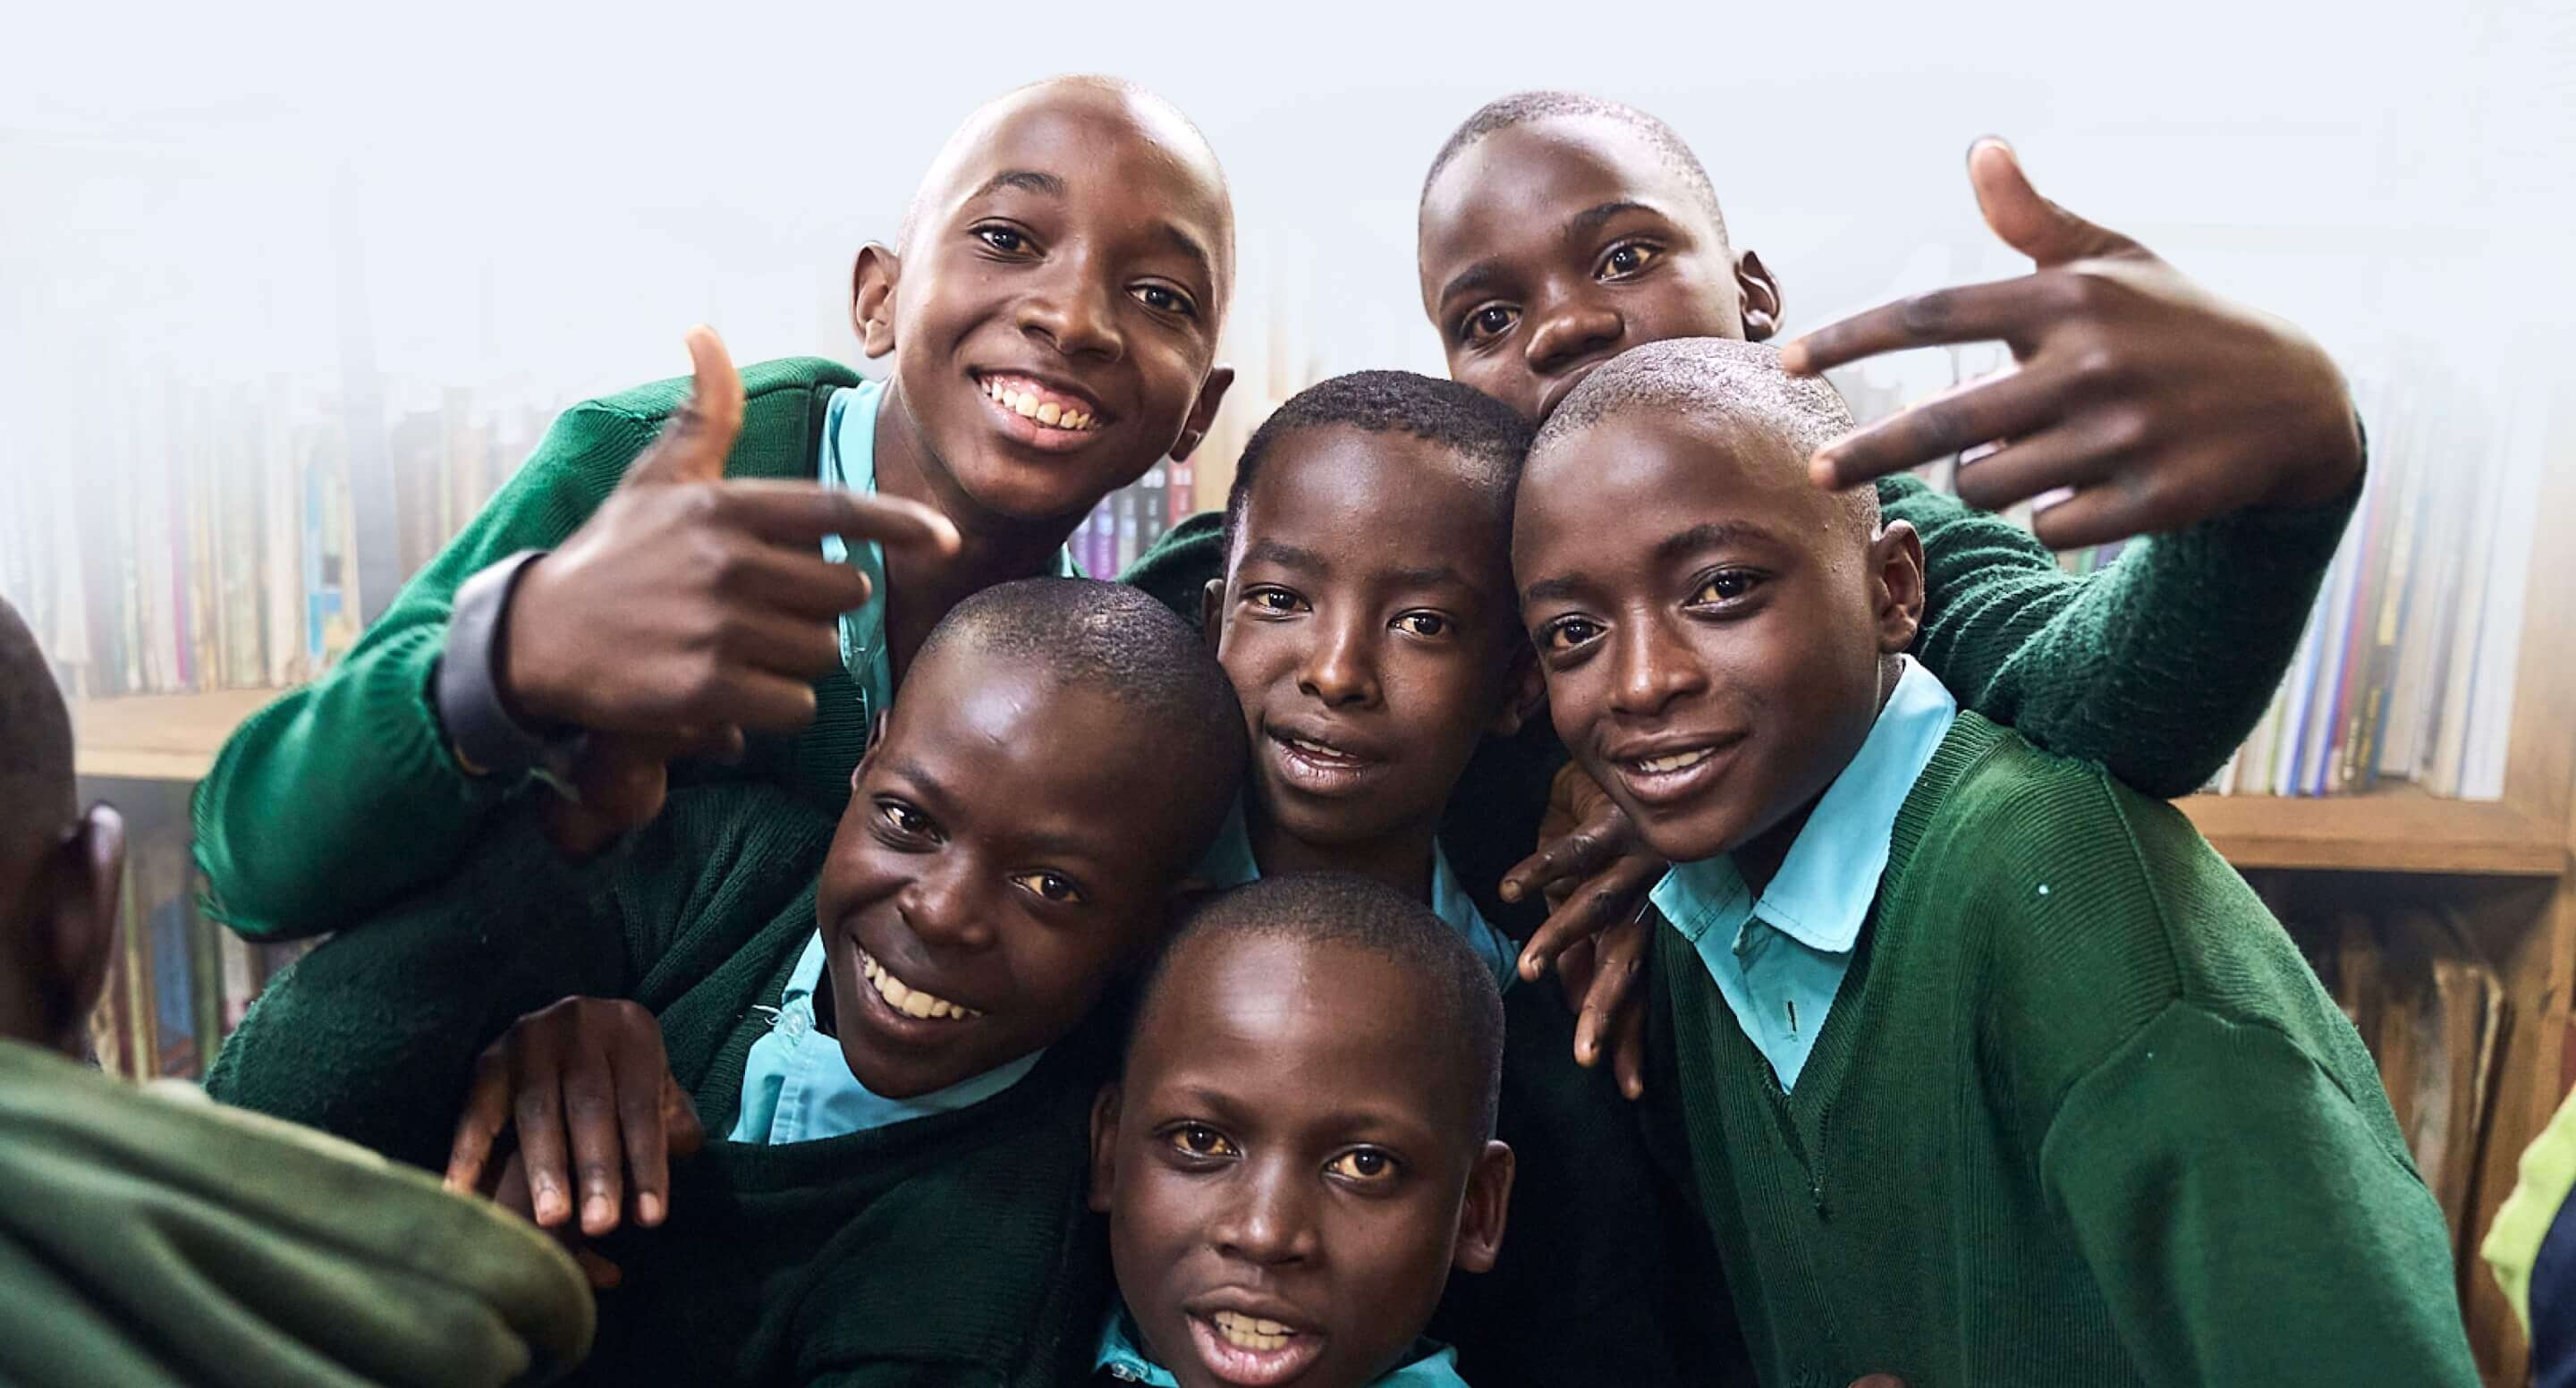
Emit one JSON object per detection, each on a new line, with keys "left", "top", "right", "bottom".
{"left": 193, "top": 358, "right": 1080, "bottom": 937}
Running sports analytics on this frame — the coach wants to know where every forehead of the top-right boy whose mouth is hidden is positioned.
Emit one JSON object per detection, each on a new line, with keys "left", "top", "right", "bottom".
{"left": 1419, "top": 116, "right": 1707, "bottom": 275}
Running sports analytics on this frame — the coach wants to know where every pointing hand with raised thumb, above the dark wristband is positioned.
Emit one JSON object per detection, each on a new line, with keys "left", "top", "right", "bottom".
{"left": 504, "top": 327, "right": 958, "bottom": 850}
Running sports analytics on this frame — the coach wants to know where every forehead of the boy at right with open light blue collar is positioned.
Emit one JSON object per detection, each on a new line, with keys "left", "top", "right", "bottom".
{"left": 1514, "top": 404, "right": 1842, "bottom": 558}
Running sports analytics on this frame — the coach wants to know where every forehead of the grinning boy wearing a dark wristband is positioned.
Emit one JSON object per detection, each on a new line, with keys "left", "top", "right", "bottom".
{"left": 928, "top": 82, "right": 1234, "bottom": 275}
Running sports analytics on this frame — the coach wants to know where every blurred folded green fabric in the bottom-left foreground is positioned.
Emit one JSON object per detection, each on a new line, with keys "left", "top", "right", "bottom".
{"left": 0, "top": 1040, "right": 592, "bottom": 1388}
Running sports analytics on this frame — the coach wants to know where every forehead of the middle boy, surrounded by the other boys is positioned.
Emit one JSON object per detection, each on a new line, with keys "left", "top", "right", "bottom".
{"left": 1236, "top": 425, "right": 1504, "bottom": 580}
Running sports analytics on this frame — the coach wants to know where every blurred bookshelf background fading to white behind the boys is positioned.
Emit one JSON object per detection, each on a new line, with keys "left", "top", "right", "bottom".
{"left": 0, "top": 0, "right": 2576, "bottom": 1375}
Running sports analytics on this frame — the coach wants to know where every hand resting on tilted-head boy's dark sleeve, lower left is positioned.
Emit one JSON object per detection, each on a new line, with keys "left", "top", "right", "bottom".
{"left": 445, "top": 996, "right": 706, "bottom": 1257}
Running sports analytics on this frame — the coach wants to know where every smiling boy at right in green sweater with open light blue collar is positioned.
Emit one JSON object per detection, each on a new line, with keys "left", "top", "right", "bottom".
{"left": 1513, "top": 340, "right": 2476, "bottom": 1388}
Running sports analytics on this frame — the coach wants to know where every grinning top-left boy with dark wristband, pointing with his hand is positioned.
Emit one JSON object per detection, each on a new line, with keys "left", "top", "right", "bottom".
{"left": 196, "top": 77, "right": 1234, "bottom": 935}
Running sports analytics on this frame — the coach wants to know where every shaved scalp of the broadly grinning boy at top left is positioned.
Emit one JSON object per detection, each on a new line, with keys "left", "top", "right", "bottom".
{"left": 894, "top": 72, "right": 1234, "bottom": 311}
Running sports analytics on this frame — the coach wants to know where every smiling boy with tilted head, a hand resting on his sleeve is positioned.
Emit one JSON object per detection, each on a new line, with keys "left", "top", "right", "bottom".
{"left": 208, "top": 580, "right": 1244, "bottom": 1385}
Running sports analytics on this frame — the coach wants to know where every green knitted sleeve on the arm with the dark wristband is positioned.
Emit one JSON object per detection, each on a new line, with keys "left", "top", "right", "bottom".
{"left": 193, "top": 404, "right": 657, "bottom": 937}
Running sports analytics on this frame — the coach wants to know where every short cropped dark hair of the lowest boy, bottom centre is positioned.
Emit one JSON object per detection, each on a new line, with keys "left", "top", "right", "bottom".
{"left": 1136, "top": 873, "right": 1502, "bottom": 1143}
